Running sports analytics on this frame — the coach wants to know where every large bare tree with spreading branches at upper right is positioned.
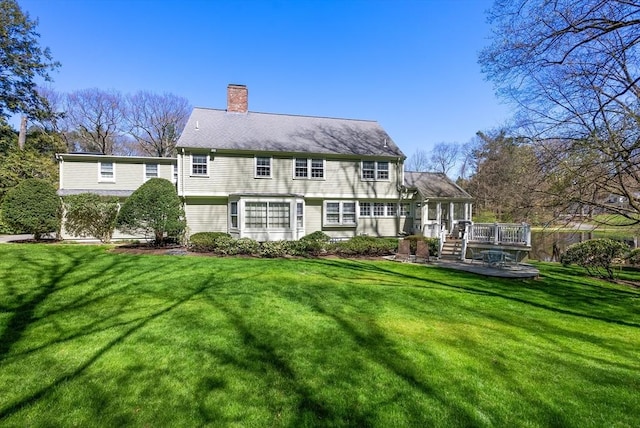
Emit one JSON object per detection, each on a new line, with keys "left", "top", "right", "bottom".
{"left": 480, "top": 0, "right": 640, "bottom": 223}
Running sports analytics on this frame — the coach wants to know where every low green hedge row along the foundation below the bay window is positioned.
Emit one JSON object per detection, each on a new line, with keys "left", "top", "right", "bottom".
{"left": 189, "top": 232, "right": 412, "bottom": 257}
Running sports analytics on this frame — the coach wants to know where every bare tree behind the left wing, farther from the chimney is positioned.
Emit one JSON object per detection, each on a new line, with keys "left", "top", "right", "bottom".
{"left": 64, "top": 88, "right": 125, "bottom": 155}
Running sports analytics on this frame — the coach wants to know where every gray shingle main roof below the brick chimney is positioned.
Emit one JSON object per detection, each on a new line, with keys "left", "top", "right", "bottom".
{"left": 177, "top": 108, "right": 404, "bottom": 157}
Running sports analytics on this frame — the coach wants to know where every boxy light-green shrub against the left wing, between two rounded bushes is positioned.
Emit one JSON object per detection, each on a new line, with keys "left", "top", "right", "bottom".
{"left": 64, "top": 193, "right": 120, "bottom": 243}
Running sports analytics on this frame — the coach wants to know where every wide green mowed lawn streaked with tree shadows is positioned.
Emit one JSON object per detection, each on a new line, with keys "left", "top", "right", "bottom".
{"left": 0, "top": 244, "right": 640, "bottom": 427}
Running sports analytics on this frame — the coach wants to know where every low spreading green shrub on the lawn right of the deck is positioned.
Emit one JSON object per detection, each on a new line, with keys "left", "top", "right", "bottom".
{"left": 560, "top": 239, "right": 629, "bottom": 279}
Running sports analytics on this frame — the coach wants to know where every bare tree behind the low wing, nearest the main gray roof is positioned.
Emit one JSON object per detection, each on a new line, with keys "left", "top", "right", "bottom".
{"left": 126, "top": 91, "right": 191, "bottom": 157}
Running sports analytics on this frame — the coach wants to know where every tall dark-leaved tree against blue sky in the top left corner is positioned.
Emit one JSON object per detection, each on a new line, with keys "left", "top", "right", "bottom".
{"left": 0, "top": 0, "right": 59, "bottom": 118}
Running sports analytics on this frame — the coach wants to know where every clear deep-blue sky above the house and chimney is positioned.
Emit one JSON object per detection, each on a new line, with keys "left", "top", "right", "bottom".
{"left": 18, "top": 0, "right": 508, "bottom": 156}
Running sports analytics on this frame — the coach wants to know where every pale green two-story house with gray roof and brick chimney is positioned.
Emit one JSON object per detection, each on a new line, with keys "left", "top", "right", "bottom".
{"left": 58, "top": 85, "right": 472, "bottom": 241}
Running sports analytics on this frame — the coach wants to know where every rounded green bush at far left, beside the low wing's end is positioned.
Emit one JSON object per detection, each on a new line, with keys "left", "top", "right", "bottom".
{"left": 2, "top": 178, "right": 62, "bottom": 239}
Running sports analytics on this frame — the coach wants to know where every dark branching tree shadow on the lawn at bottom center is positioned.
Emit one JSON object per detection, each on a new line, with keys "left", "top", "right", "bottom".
{"left": 197, "top": 289, "right": 479, "bottom": 426}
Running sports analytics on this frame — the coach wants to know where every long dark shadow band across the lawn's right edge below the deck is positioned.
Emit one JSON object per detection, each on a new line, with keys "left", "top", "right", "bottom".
{"left": 292, "top": 259, "right": 640, "bottom": 327}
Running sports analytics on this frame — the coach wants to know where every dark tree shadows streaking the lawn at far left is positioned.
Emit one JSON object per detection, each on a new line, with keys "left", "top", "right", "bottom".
{"left": 0, "top": 247, "right": 244, "bottom": 421}
